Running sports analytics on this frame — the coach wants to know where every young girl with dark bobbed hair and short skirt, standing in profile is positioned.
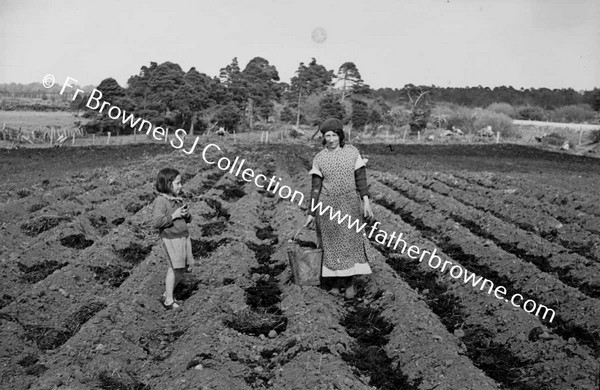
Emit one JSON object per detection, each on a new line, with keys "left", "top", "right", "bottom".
{"left": 152, "top": 168, "right": 194, "bottom": 310}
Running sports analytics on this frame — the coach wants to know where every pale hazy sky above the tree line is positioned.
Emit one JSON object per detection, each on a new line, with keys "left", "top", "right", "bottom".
{"left": 0, "top": 0, "right": 600, "bottom": 90}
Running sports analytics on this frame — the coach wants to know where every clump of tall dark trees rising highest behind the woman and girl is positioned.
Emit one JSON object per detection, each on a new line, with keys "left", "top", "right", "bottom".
{"left": 71, "top": 57, "right": 370, "bottom": 134}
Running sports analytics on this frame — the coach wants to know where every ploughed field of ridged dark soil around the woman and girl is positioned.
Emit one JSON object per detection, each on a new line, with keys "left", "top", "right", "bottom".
{"left": 0, "top": 140, "right": 600, "bottom": 390}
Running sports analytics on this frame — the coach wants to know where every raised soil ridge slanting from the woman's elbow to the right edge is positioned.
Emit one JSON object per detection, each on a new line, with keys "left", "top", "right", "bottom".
{"left": 374, "top": 179, "right": 600, "bottom": 351}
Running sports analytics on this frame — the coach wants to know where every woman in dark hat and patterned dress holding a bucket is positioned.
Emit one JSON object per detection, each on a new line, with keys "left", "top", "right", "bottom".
{"left": 306, "top": 118, "right": 373, "bottom": 298}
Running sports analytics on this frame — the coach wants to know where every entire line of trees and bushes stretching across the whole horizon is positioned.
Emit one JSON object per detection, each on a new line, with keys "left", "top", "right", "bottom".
{"left": 0, "top": 57, "right": 600, "bottom": 134}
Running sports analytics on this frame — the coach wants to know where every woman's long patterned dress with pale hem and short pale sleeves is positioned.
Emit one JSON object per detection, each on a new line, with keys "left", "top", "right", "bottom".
{"left": 309, "top": 144, "right": 372, "bottom": 277}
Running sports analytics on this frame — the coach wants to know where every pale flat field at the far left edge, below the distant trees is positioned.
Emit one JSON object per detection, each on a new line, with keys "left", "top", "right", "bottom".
{"left": 0, "top": 111, "right": 86, "bottom": 134}
